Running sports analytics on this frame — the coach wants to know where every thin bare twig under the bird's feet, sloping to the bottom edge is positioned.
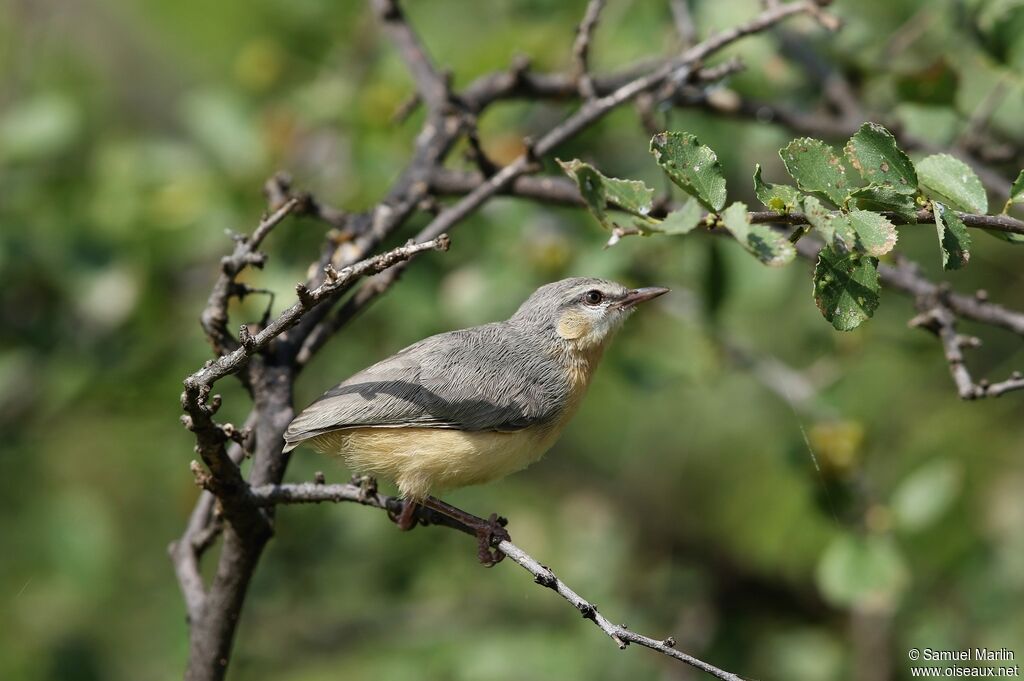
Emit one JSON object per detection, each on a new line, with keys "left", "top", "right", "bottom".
{"left": 250, "top": 482, "right": 742, "bottom": 681}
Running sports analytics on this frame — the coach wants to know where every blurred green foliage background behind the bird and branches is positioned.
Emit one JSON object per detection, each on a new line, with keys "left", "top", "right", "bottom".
{"left": 0, "top": 0, "right": 1024, "bottom": 681}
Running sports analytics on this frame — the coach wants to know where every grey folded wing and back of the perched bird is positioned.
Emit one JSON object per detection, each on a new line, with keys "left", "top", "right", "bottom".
{"left": 285, "top": 324, "right": 565, "bottom": 444}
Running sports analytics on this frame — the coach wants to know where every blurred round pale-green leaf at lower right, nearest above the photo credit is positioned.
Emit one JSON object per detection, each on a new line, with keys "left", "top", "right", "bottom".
{"left": 816, "top": 535, "right": 907, "bottom": 608}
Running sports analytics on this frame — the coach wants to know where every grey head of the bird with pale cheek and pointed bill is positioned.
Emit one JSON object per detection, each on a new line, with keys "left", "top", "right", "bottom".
{"left": 510, "top": 278, "right": 669, "bottom": 351}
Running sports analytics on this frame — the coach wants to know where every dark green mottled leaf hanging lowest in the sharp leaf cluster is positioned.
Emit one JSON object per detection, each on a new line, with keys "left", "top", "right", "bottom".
{"left": 814, "top": 246, "right": 880, "bottom": 331}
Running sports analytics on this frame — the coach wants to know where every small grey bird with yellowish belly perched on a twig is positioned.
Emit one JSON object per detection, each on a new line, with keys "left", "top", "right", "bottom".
{"left": 284, "top": 278, "right": 669, "bottom": 565}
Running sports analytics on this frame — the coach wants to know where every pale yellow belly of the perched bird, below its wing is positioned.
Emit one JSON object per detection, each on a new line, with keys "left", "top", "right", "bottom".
{"left": 310, "top": 428, "right": 558, "bottom": 499}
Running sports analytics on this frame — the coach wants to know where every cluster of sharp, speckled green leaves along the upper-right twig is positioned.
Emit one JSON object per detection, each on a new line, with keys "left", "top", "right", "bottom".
{"left": 559, "top": 123, "right": 1024, "bottom": 331}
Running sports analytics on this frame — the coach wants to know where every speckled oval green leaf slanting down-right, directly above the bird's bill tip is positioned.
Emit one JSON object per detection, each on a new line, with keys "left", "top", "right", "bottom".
{"left": 650, "top": 132, "right": 725, "bottom": 212}
